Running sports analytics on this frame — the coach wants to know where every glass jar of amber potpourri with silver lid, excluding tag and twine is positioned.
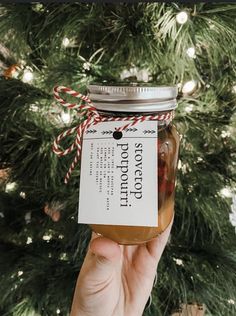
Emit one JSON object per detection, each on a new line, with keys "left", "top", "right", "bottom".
{"left": 89, "top": 85, "right": 180, "bottom": 245}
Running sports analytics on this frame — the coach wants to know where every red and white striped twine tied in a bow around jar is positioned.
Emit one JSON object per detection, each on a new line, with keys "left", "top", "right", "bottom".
{"left": 52, "top": 86, "right": 173, "bottom": 184}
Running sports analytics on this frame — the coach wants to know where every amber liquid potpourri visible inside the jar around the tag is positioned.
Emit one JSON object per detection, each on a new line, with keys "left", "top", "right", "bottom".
{"left": 90, "top": 124, "right": 179, "bottom": 245}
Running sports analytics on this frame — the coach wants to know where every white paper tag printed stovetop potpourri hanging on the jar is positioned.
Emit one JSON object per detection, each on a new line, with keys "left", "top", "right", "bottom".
{"left": 78, "top": 121, "right": 158, "bottom": 227}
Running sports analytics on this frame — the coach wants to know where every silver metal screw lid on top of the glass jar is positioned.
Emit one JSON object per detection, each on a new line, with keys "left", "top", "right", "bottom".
{"left": 88, "top": 85, "right": 178, "bottom": 112}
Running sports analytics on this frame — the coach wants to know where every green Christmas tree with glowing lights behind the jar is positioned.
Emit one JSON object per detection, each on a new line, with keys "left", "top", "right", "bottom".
{"left": 0, "top": 3, "right": 236, "bottom": 316}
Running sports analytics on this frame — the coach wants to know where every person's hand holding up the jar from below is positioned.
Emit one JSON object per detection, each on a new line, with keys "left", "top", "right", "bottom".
{"left": 71, "top": 223, "right": 172, "bottom": 316}
